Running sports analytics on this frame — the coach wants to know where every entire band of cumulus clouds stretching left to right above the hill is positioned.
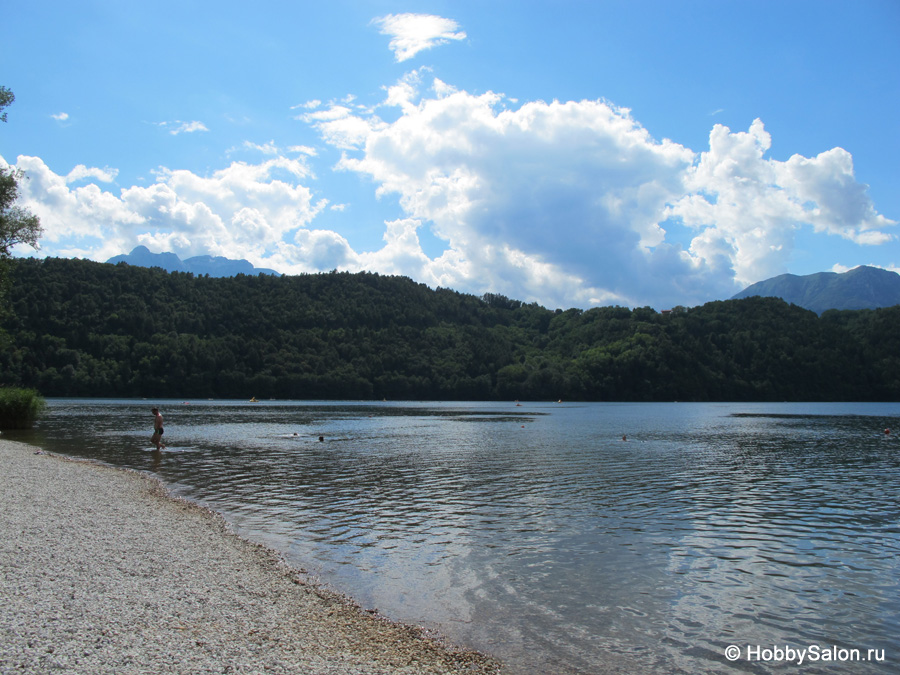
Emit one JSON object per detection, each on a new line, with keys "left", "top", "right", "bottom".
{"left": 0, "top": 69, "right": 895, "bottom": 308}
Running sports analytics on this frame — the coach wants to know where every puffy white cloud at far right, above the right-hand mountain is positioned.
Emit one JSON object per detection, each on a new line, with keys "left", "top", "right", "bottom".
{"left": 669, "top": 120, "right": 896, "bottom": 285}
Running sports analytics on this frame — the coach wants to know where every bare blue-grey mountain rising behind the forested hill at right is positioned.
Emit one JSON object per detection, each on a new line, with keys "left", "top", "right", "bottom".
{"left": 732, "top": 266, "right": 900, "bottom": 314}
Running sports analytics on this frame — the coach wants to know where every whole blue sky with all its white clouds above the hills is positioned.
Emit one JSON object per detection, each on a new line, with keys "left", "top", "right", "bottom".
{"left": 0, "top": 0, "right": 900, "bottom": 310}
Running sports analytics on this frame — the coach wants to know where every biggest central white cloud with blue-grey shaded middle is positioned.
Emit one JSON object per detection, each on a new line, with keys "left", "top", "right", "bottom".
{"left": 318, "top": 80, "right": 693, "bottom": 304}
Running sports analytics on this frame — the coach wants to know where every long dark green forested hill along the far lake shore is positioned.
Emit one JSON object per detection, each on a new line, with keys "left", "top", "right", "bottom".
{"left": 0, "top": 258, "right": 900, "bottom": 401}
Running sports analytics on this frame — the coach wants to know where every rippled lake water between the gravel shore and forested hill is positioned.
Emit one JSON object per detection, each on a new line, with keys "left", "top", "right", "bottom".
{"left": 4, "top": 400, "right": 900, "bottom": 673}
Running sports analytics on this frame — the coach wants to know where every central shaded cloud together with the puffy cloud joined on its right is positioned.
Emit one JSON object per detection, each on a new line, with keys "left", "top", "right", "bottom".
{"left": 307, "top": 71, "right": 894, "bottom": 307}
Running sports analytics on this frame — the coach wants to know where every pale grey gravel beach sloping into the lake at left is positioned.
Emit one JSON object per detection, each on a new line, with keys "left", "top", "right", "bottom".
{"left": 0, "top": 441, "right": 501, "bottom": 675}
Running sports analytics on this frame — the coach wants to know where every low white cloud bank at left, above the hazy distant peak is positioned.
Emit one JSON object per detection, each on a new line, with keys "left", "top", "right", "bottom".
{"left": 0, "top": 156, "right": 327, "bottom": 263}
